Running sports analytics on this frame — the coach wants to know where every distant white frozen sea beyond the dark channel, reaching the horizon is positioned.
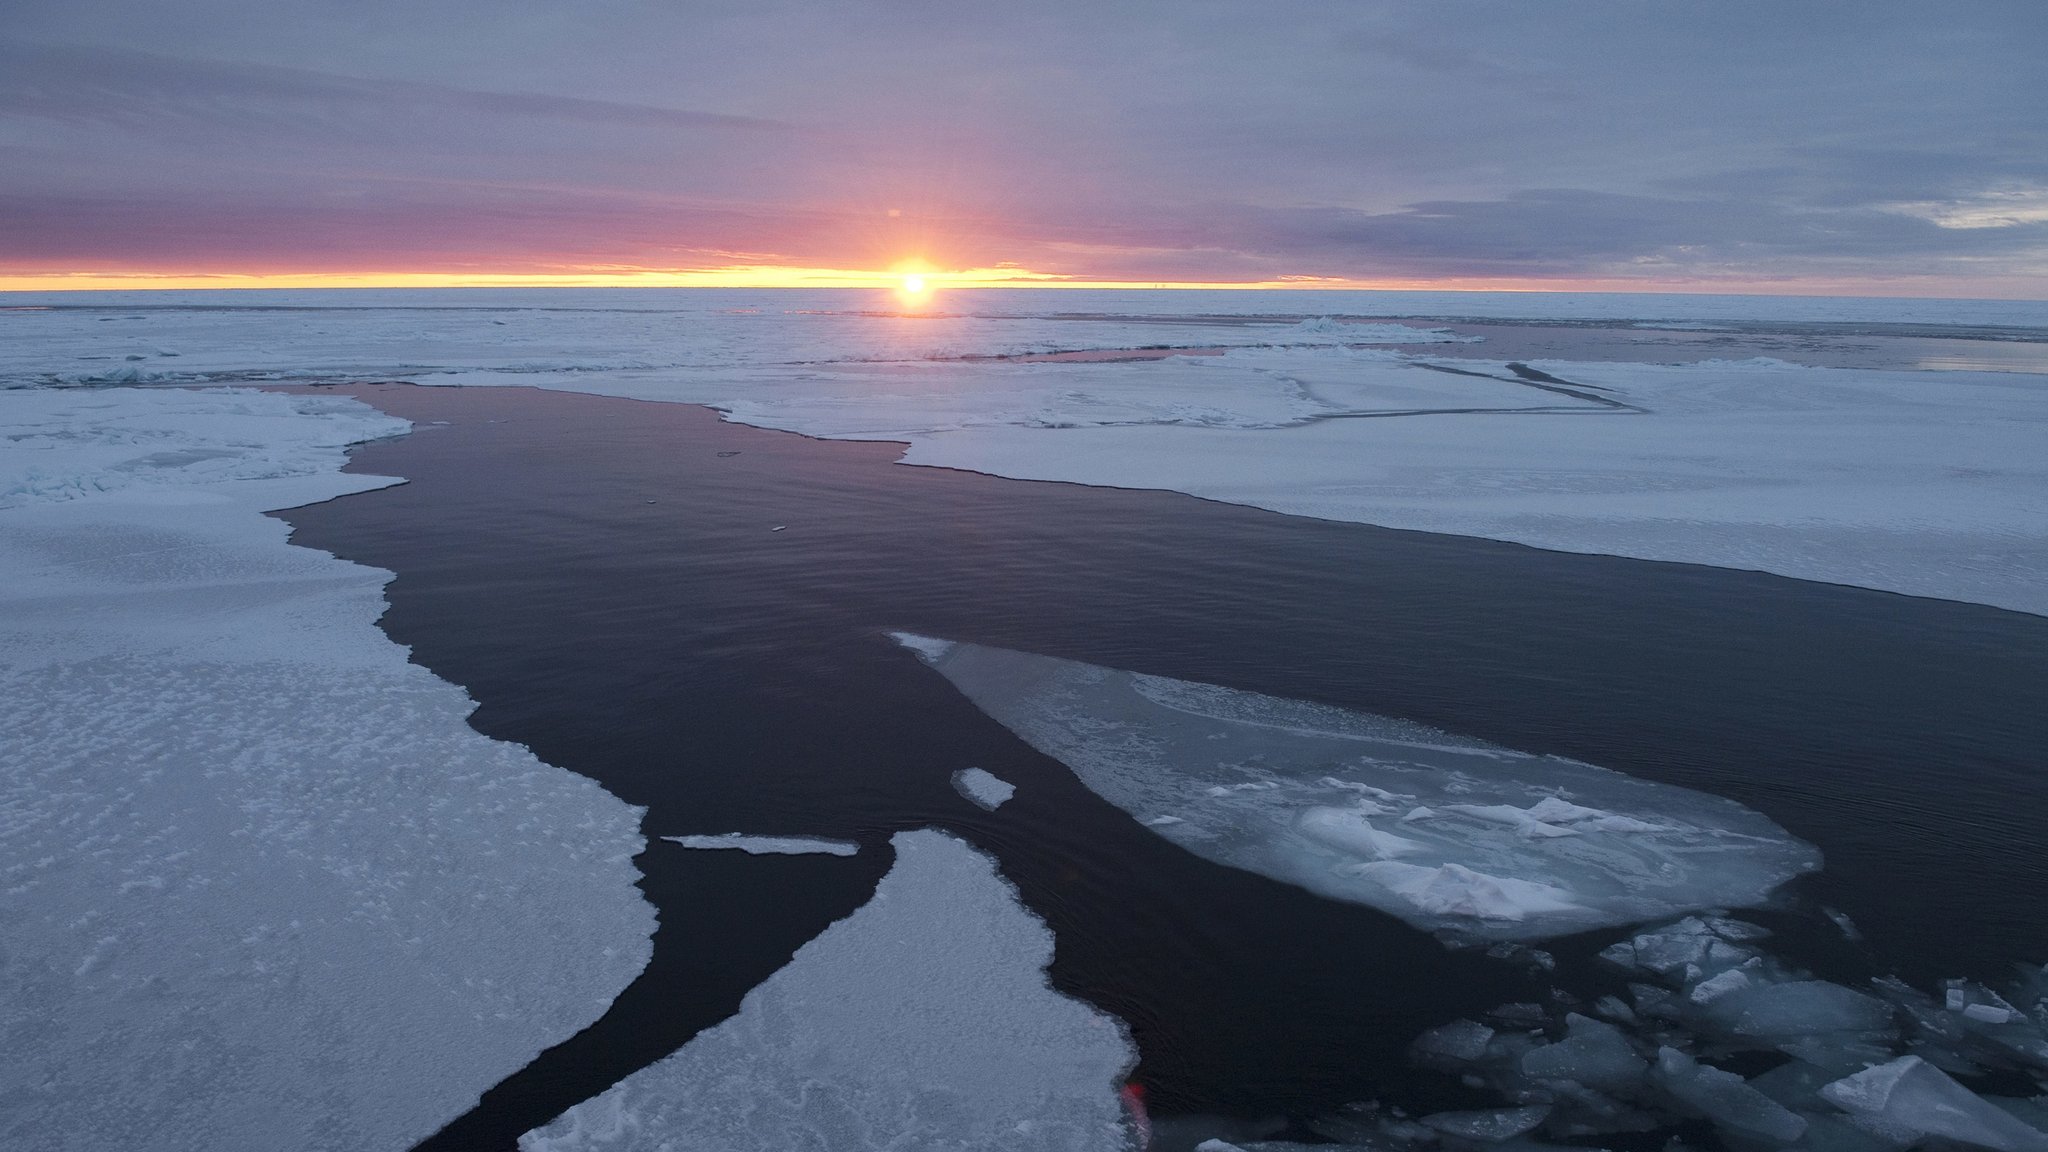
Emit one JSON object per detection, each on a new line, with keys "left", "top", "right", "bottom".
{"left": 0, "top": 289, "right": 2048, "bottom": 613}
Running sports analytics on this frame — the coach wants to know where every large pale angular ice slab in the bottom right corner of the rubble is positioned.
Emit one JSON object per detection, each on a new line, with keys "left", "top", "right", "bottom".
{"left": 1821, "top": 1056, "right": 2048, "bottom": 1152}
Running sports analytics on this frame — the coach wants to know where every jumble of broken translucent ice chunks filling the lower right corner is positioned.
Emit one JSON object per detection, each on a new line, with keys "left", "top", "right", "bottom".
{"left": 1327, "top": 916, "right": 2048, "bottom": 1152}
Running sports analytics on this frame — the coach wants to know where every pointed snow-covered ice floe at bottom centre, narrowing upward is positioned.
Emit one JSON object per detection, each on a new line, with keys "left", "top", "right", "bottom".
{"left": 520, "top": 830, "right": 1135, "bottom": 1152}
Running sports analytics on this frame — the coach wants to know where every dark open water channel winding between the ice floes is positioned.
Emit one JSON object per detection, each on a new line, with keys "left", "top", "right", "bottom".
{"left": 285, "top": 385, "right": 2048, "bottom": 1148}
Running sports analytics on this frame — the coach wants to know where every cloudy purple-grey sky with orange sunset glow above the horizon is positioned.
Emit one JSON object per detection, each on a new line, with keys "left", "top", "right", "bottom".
{"left": 0, "top": 0, "right": 2048, "bottom": 299}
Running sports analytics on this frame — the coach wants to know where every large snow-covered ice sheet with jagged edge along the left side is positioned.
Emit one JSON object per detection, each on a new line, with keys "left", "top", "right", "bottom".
{"left": 0, "top": 389, "right": 653, "bottom": 1152}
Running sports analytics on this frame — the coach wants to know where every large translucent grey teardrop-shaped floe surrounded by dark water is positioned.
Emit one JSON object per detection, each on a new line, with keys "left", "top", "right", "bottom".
{"left": 899, "top": 635, "right": 1819, "bottom": 941}
